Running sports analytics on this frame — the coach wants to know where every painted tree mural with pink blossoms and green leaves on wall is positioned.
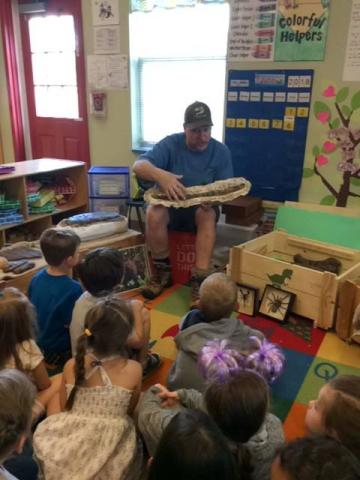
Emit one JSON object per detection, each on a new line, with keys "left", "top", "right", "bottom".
{"left": 303, "top": 85, "right": 360, "bottom": 207}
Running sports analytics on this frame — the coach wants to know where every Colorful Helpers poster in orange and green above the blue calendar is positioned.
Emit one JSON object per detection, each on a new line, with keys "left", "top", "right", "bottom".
{"left": 275, "top": 0, "right": 330, "bottom": 61}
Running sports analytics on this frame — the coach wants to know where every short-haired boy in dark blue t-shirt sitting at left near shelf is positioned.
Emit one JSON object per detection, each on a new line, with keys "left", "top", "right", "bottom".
{"left": 29, "top": 228, "right": 82, "bottom": 368}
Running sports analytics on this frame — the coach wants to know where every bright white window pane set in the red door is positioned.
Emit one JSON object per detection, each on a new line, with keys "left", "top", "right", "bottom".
{"left": 29, "top": 15, "right": 79, "bottom": 118}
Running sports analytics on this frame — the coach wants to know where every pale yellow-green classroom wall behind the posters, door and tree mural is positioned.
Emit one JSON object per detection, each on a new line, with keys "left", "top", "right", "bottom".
{"left": 0, "top": 0, "right": 360, "bottom": 206}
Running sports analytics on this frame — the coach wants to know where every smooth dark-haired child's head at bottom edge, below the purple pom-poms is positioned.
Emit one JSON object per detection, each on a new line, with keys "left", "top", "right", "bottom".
{"left": 147, "top": 410, "right": 246, "bottom": 480}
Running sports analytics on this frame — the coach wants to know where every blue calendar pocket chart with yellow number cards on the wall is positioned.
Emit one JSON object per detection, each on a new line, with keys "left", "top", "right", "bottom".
{"left": 225, "top": 70, "right": 314, "bottom": 202}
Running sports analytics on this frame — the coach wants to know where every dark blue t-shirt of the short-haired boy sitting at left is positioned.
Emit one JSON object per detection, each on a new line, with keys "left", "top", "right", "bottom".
{"left": 29, "top": 269, "right": 82, "bottom": 353}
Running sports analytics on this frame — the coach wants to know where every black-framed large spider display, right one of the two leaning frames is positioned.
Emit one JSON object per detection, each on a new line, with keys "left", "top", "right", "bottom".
{"left": 259, "top": 285, "right": 296, "bottom": 322}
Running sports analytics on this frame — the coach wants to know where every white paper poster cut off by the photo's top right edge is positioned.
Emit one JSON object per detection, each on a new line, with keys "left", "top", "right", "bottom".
{"left": 343, "top": 0, "right": 360, "bottom": 82}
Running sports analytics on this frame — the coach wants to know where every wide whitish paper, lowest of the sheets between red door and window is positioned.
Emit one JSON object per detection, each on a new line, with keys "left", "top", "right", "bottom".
{"left": 87, "top": 55, "right": 129, "bottom": 89}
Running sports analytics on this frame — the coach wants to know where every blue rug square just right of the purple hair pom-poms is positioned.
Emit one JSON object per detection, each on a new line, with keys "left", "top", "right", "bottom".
{"left": 271, "top": 348, "right": 314, "bottom": 401}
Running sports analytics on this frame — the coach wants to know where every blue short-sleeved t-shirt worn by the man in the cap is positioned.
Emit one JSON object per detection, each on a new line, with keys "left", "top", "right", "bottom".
{"left": 140, "top": 133, "right": 234, "bottom": 187}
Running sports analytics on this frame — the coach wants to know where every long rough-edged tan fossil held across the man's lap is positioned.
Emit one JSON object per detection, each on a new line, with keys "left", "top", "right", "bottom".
{"left": 144, "top": 177, "right": 251, "bottom": 208}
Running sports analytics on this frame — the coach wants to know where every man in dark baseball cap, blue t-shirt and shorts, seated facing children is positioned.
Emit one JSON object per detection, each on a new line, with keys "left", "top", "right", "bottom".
{"left": 134, "top": 101, "right": 234, "bottom": 308}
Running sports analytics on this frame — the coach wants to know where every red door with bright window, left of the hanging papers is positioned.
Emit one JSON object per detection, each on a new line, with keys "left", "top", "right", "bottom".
{"left": 20, "top": 0, "right": 90, "bottom": 163}
